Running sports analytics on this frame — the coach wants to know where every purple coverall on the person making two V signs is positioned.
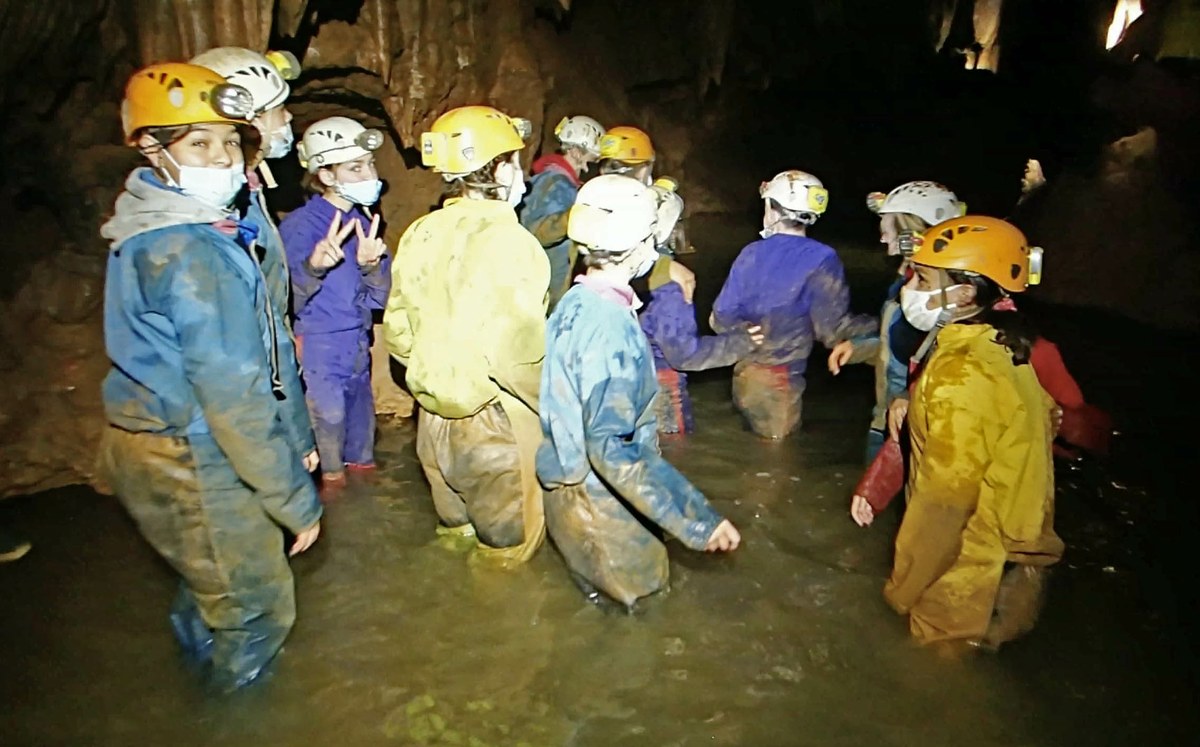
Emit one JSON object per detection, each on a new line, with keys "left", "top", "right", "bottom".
{"left": 280, "top": 197, "right": 391, "bottom": 473}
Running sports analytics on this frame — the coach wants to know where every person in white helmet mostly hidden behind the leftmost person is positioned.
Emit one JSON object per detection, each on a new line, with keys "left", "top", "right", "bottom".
{"left": 192, "top": 47, "right": 317, "bottom": 480}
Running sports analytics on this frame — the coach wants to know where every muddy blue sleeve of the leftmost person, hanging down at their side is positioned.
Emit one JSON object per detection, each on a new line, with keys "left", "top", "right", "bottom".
{"left": 154, "top": 246, "right": 322, "bottom": 532}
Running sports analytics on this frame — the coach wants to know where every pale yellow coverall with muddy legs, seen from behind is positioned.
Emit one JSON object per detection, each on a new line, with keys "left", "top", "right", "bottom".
{"left": 384, "top": 199, "right": 550, "bottom": 563}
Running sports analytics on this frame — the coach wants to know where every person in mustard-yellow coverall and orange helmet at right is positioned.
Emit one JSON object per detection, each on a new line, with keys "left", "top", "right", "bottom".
{"left": 868, "top": 215, "right": 1063, "bottom": 646}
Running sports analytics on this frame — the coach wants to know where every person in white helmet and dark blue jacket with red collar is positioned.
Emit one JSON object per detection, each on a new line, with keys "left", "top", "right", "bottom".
{"left": 521, "top": 115, "right": 605, "bottom": 310}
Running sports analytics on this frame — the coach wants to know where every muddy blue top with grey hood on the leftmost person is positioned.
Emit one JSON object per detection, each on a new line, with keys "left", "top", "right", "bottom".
{"left": 102, "top": 169, "right": 316, "bottom": 514}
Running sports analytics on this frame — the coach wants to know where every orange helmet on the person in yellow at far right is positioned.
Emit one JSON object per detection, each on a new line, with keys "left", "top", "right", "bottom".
{"left": 912, "top": 215, "right": 1042, "bottom": 293}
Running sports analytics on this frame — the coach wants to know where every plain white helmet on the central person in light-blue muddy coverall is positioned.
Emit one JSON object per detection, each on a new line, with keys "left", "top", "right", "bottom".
{"left": 566, "top": 174, "right": 659, "bottom": 257}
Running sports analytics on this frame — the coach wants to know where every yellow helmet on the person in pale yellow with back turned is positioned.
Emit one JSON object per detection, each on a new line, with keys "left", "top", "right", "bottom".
{"left": 421, "top": 106, "right": 533, "bottom": 179}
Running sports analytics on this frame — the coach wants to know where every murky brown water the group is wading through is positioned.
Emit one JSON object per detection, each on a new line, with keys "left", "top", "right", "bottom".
{"left": 0, "top": 213, "right": 1196, "bottom": 747}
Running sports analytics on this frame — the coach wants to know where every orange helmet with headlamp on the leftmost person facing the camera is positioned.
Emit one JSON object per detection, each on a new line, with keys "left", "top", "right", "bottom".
{"left": 121, "top": 62, "right": 254, "bottom": 144}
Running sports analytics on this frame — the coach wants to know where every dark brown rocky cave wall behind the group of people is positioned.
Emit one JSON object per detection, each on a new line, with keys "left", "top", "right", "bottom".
{"left": 0, "top": 0, "right": 1200, "bottom": 495}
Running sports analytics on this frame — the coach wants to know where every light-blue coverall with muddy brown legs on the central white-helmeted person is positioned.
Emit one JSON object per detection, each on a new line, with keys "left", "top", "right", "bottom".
{"left": 538, "top": 283, "right": 721, "bottom": 605}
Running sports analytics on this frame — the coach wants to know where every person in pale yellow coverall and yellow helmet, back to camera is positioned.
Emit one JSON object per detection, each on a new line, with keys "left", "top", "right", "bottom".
{"left": 384, "top": 106, "right": 550, "bottom": 560}
